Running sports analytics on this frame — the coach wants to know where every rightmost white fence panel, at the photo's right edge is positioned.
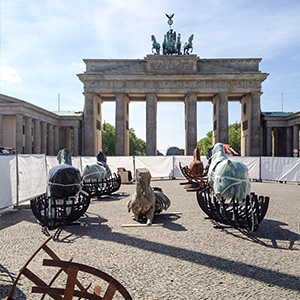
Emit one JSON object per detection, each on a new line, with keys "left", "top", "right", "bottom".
{"left": 261, "top": 157, "right": 300, "bottom": 182}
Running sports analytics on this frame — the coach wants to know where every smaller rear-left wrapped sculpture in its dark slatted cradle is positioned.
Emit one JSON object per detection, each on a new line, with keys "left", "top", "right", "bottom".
{"left": 82, "top": 151, "right": 121, "bottom": 198}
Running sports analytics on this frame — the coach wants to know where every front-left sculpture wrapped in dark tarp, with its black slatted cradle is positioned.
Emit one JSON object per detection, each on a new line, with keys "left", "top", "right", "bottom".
{"left": 30, "top": 149, "right": 91, "bottom": 230}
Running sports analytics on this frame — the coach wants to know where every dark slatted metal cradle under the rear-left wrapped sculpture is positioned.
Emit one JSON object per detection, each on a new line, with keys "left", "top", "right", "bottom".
{"left": 82, "top": 173, "right": 121, "bottom": 198}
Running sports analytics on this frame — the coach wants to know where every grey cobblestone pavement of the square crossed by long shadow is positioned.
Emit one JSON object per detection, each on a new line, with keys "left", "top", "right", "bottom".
{"left": 0, "top": 179, "right": 300, "bottom": 300}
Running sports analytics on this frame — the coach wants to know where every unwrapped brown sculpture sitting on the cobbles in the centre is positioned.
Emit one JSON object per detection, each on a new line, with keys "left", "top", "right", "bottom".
{"left": 127, "top": 168, "right": 170, "bottom": 225}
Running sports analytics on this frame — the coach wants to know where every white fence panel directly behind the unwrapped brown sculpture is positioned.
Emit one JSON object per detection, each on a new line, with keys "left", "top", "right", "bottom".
{"left": 135, "top": 156, "right": 173, "bottom": 178}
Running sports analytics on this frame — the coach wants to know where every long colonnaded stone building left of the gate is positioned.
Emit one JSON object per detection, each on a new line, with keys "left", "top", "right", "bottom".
{"left": 0, "top": 94, "right": 82, "bottom": 156}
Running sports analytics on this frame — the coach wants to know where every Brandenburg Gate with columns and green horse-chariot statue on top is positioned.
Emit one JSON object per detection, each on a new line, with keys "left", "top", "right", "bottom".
{"left": 78, "top": 15, "right": 268, "bottom": 156}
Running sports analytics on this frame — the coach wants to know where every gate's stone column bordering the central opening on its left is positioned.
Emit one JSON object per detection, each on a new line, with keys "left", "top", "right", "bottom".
{"left": 146, "top": 93, "right": 157, "bottom": 156}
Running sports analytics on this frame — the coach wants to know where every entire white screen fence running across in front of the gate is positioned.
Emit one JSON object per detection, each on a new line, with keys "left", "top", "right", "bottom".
{"left": 0, "top": 154, "right": 300, "bottom": 209}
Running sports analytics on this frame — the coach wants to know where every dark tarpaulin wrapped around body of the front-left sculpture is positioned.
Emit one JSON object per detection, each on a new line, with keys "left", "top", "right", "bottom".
{"left": 48, "top": 165, "right": 81, "bottom": 199}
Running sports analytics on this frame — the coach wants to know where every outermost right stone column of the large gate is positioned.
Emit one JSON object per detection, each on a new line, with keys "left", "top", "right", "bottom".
{"left": 248, "top": 92, "right": 262, "bottom": 156}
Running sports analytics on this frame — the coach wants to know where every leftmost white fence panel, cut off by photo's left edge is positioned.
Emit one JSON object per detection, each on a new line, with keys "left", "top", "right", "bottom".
{"left": 0, "top": 155, "right": 17, "bottom": 209}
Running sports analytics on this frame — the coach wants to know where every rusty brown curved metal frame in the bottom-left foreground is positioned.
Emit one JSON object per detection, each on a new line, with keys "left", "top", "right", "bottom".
{"left": 5, "top": 237, "right": 132, "bottom": 300}
